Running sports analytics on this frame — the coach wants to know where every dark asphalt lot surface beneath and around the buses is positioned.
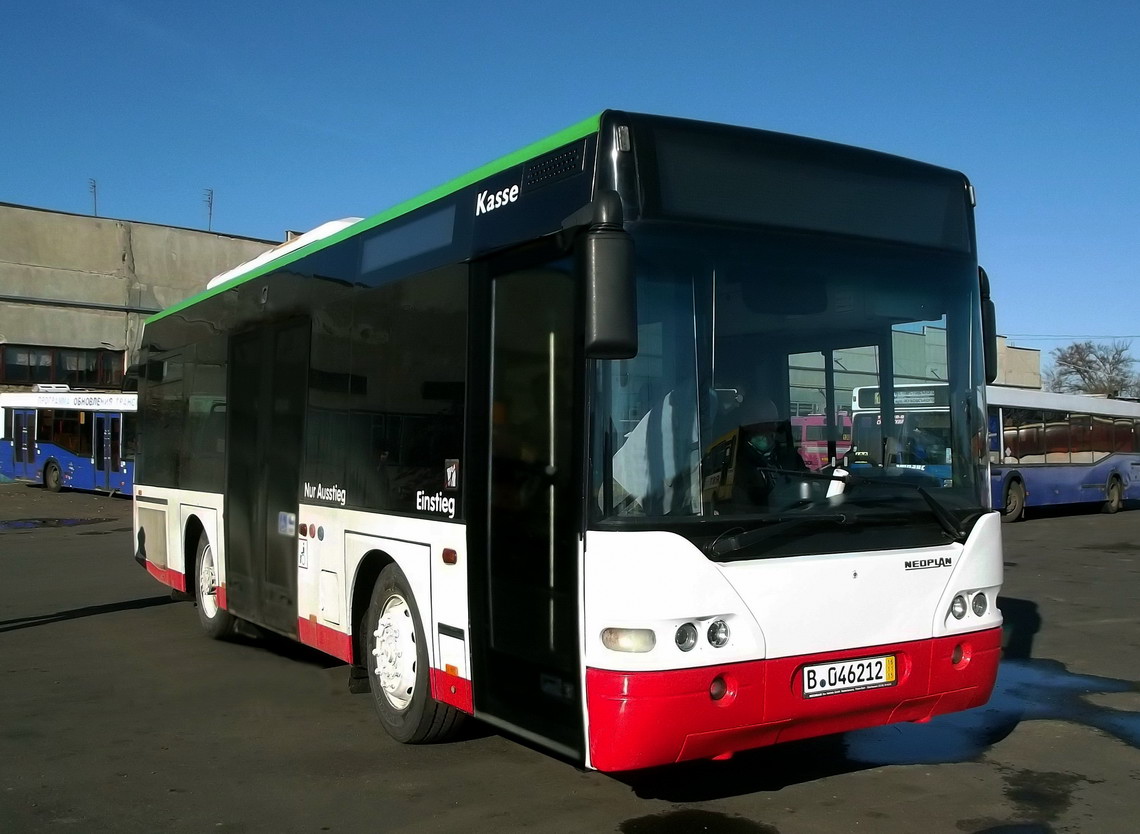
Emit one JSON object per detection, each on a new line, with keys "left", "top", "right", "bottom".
{"left": 0, "top": 484, "right": 1140, "bottom": 834}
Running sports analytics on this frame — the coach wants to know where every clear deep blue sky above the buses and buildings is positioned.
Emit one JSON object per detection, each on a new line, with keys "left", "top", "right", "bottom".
{"left": 0, "top": 0, "right": 1140, "bottom": 355}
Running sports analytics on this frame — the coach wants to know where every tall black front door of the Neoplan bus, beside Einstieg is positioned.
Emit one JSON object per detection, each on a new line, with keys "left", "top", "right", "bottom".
{"left": 469, "top": 258, "right": 583, "bottom": 760}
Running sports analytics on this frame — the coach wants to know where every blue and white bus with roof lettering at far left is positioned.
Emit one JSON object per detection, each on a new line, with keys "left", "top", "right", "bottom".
{"left": 0, "top": 385, "right": 138, "bottom": 496}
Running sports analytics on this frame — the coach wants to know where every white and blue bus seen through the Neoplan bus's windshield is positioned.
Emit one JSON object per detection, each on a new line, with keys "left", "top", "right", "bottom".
{"left": 848, "top": 382, "right": 955, "bottom": 483}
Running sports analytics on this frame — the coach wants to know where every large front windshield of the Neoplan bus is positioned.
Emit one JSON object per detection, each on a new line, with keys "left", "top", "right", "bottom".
{"left": 592, "top": 223, "right": 986, "bottom": 544}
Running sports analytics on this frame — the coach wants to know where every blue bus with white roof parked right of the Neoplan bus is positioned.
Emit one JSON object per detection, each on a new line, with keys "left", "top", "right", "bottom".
{"left": 986, "top": 385, "right": 1140, "bottom": 522}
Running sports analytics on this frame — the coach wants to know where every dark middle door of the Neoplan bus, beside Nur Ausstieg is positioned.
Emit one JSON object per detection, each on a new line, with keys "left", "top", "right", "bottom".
{"left": 226, "top": 320, "right": 310, "bottom": 637}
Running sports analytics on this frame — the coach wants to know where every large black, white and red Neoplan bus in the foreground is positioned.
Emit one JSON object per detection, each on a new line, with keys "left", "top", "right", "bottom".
{"left": 133, "top": 111, "right": 1002, "bottom": 771}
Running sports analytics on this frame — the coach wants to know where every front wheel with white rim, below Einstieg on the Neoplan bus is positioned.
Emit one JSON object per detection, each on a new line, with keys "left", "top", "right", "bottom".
{"left": 369, "top": 565, "right": 464, "bottom": 744}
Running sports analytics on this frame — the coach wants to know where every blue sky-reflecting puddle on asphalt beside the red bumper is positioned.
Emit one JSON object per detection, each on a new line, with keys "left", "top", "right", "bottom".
{"left": 844, "top": 660, "right": 1140, "bottom": 765}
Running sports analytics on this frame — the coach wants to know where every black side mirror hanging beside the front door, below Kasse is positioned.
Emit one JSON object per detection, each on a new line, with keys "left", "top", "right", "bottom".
{"left": 581, "top": 191, "right": 637, "bottom": 359}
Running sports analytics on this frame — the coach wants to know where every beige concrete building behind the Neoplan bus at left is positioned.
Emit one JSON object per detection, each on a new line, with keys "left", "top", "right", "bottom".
{"left": 0, "top": 203, "right": 277, "bottom": 391}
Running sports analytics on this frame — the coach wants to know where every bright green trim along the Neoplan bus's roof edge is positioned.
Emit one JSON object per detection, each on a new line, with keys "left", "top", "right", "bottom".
{"left": 146, "top": 113, "right": 602, "bottom": 325}
